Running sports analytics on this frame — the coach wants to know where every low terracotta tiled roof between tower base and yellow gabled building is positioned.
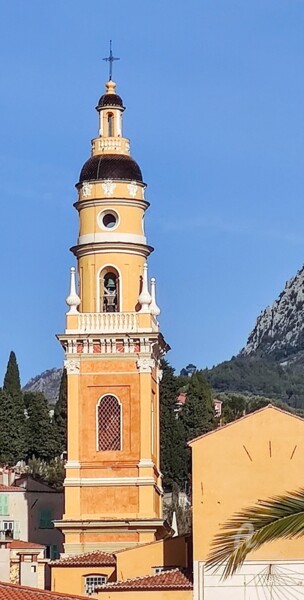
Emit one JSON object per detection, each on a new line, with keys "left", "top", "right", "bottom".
{"left": 99, "top": 569, "right": 193, "bottom": 592}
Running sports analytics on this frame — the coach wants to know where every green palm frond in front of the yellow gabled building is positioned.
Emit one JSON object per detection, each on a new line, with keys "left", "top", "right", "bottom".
{"left": 207, "top": 489, "right": 304, "bottom": 579}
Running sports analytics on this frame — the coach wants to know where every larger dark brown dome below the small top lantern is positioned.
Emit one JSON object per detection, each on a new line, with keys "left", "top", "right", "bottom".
{"left": 79, "top": 154, "right": 143, "bottom": 183}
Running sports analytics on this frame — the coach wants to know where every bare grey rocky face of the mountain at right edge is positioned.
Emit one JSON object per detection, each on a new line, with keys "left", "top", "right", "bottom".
{"left": 241, "top": 267, "right": 304, "bottom": 364}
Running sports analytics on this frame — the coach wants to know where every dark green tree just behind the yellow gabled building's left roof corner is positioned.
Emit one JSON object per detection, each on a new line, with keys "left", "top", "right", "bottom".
{"left": 182, "top": 371, "right": 215, "bottom": 441}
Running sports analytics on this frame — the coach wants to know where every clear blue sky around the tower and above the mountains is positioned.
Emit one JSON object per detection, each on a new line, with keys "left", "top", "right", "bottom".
{"left": 0, "top": 0, "right": 304, "bottom": 383}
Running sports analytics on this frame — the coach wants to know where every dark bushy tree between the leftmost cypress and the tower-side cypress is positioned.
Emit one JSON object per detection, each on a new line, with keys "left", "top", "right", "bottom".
{"left": 24, "top": 392, "right": 56, "bottom": 460}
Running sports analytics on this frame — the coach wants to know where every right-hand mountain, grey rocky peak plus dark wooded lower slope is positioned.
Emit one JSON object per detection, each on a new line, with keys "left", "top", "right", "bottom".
{"left": 206, "top": 267, "right": 304, "bottom": 409}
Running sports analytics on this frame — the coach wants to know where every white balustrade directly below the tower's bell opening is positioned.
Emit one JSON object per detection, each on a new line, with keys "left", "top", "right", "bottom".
{"left": 78, "top": 312, "right": 139, "bottom": 333}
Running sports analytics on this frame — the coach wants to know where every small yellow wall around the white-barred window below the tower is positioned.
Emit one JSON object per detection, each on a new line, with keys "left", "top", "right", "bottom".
{"left": 51, "top": 567, "right": 115, "bottom": 596}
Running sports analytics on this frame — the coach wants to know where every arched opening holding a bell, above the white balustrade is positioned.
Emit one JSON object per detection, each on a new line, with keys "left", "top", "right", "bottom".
{"left": 97, "top": 265, "right": 121, "bottom": 312}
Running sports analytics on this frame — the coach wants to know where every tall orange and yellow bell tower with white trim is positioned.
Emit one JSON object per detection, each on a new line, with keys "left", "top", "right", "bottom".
{"left": 55, "top": 79, "right": 170, "bottom": 554}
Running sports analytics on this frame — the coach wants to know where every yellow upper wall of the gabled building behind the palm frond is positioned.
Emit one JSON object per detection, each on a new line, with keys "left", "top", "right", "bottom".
{"left": 190, "top": 407, "right": 304, "bottom": 560}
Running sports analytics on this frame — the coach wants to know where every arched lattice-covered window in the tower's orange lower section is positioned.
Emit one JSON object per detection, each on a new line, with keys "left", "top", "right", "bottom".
{"left": 97, "top": 395, "right": 121, "bottom": 451}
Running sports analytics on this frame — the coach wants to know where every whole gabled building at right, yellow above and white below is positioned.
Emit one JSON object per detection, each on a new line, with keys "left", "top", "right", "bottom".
{"left": 190, "top": 405, "right": 304, "bottom": 600}
